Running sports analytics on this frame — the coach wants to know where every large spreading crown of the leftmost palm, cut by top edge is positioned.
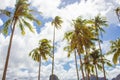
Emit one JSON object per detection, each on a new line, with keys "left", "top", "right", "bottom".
{"left": 1, "top": 0, "right": 41, "bottom": 35}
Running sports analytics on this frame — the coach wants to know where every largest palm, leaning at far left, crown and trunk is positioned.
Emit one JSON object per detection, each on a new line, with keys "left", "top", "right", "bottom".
{"left": 2, "top": 0, "right": 41, "bottom": 80}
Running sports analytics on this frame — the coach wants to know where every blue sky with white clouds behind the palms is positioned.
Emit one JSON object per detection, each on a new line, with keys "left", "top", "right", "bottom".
{"left": 0, "top": 0, "right": 120, "bottom": 80}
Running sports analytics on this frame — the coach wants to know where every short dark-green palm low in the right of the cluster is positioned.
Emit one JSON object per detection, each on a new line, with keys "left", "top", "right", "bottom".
{"left": 89, "top": 48, "right": 112, "bottom": 80}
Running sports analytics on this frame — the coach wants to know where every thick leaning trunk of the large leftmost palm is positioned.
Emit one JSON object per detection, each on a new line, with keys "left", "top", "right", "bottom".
{"left": 2, "top": 20, "right": 17, "bottom": 80}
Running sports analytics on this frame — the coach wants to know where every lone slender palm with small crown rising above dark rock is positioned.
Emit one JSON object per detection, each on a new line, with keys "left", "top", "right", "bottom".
{"left": 51, "top": 16, "right": 63, "bottom": 75}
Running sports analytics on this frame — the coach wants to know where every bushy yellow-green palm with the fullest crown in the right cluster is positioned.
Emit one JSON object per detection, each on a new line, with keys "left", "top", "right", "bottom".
{"left": 65, "top": 17, "right": 94, "bottom": 80}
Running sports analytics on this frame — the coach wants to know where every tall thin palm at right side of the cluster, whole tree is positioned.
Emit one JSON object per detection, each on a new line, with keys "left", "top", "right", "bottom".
{"left": 92, "top": 14, "right": 108, "bottom": 80}
